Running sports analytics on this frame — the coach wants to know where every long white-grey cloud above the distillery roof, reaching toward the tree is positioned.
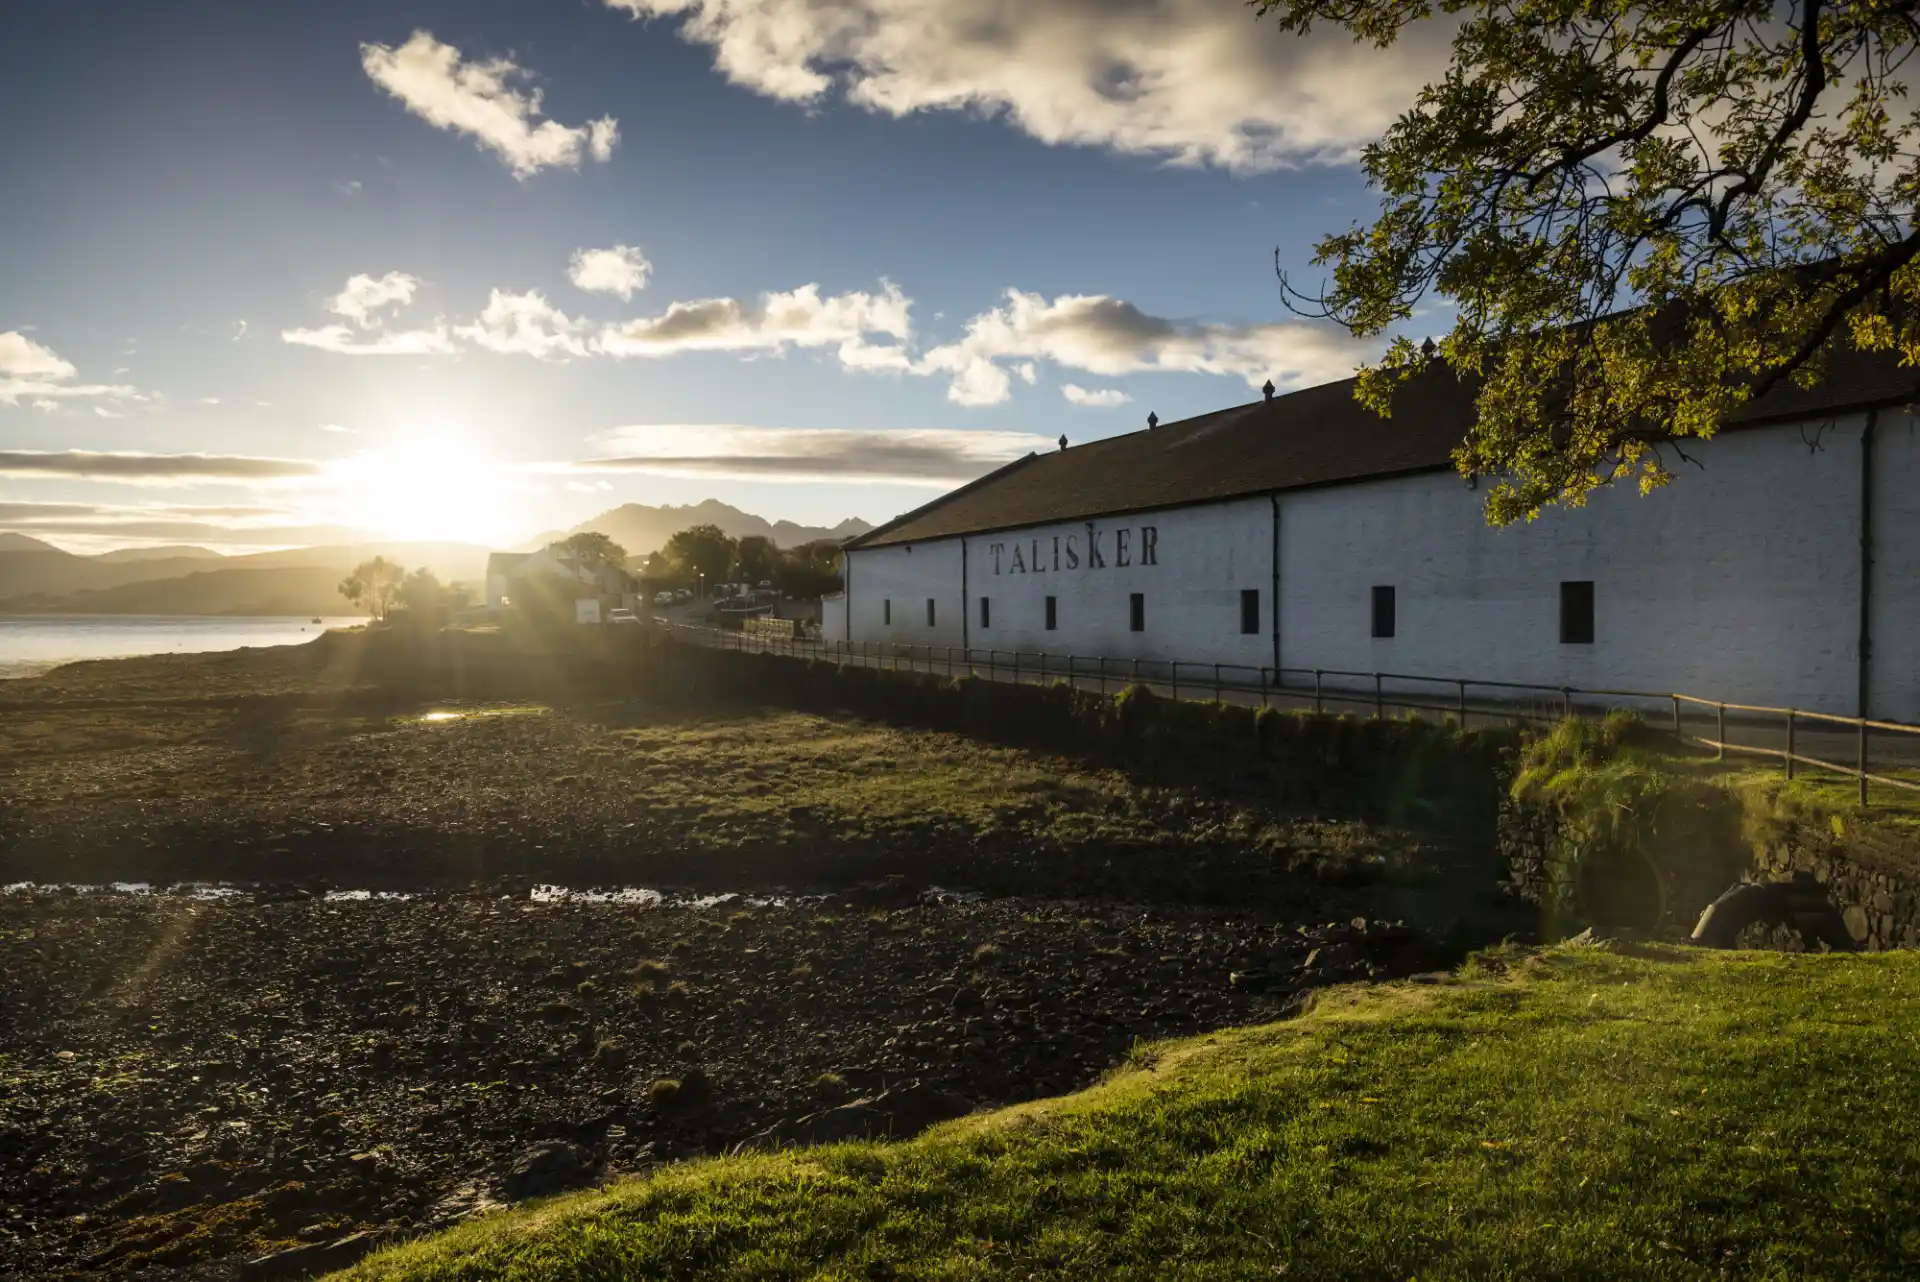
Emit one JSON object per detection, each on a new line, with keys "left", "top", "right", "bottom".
{"left": 914, "top": 290, "right": 1373, "bottom": 405}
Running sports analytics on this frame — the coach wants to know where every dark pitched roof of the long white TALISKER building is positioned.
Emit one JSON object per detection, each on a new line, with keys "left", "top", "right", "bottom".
{"left": 847, "top": 351, "right": 1920, "bottom": 549}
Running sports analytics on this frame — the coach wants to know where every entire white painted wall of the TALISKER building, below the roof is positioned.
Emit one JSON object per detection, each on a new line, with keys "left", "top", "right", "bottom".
{"left": 849, "top": 413, "right": 1920, "bottom": 722}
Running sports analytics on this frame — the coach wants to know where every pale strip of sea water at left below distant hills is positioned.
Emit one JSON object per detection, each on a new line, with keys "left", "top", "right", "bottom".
{"left": 0, "top": 614, "right": 367, "bottom": 677}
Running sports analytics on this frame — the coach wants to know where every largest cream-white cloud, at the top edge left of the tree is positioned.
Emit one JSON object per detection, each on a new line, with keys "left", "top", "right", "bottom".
{"left": 605, "top": 0, "right": 1452, "bottom": 171}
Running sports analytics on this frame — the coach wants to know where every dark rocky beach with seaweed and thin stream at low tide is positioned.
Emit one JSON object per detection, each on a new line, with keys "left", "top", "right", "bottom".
{"left": 0, "top": 647, "right": 1515, "bottom": 1278}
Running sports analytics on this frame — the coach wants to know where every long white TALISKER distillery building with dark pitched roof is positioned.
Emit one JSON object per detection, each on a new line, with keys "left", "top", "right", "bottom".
{"left": 824, "top": 357, "right": 1920, "bottom": 722}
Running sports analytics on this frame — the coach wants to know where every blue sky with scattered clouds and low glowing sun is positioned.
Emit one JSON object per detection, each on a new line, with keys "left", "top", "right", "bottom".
{"left": 0, "top": 0, "right": 1432, "bottom": 551}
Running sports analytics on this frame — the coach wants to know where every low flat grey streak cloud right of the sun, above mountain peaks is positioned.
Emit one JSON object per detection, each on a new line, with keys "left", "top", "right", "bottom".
{"left": 564, "top": 424, "right": 1050, "bottom": 486}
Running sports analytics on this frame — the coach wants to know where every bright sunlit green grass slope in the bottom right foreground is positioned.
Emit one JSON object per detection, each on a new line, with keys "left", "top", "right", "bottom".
{"left": 346, "top": 948, "right": 1920, "bottom": 1282}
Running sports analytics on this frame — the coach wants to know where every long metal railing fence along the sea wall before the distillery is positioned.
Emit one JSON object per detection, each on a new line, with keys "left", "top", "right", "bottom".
{"left": 670, "top": 624, "right": 1920, "bottom": 806}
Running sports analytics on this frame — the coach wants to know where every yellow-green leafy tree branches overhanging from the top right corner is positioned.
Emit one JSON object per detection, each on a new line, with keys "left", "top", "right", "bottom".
{"left": 1256, "top": 0, "right": 1920, "bottom": 524}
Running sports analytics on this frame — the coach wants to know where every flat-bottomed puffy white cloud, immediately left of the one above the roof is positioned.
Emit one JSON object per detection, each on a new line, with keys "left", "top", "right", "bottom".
{"left": 597, "top": 280, "right": 912, "bottom": 360}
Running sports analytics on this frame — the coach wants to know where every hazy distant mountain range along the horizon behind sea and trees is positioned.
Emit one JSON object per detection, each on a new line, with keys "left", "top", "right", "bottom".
{"left": 0, "top": 499, "right": 872, "bottom": 614}
